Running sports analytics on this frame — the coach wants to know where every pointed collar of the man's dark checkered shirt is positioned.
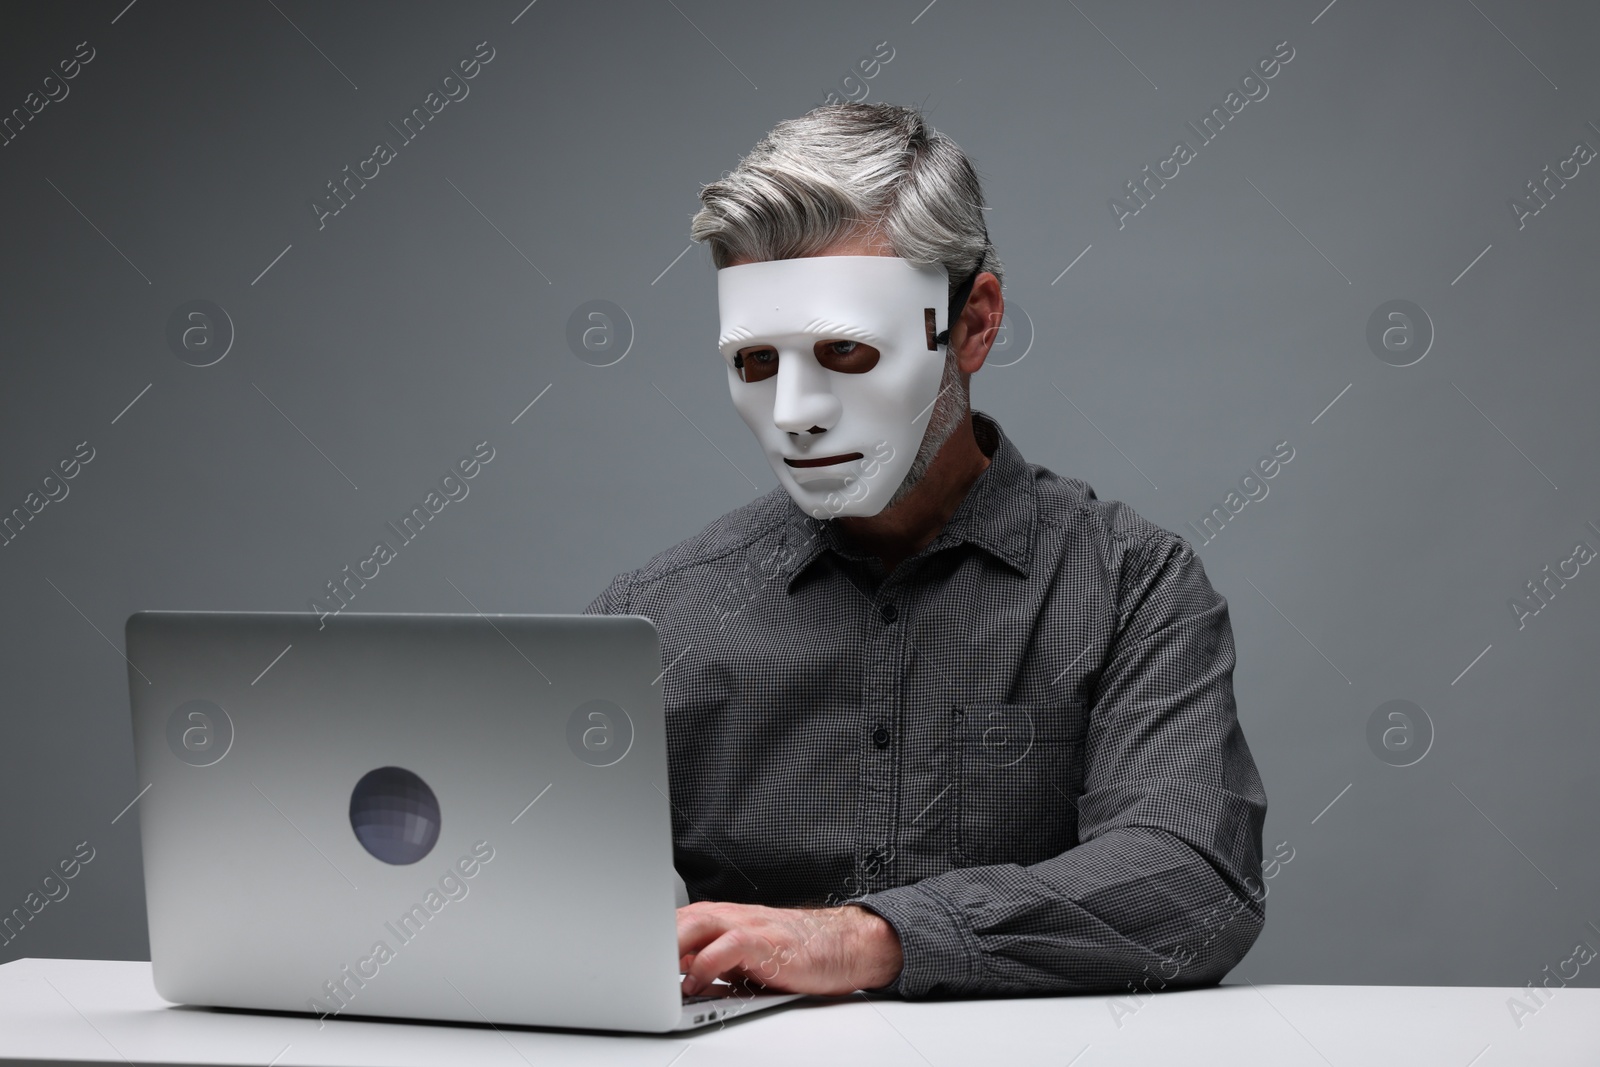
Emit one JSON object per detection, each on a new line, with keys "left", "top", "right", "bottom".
{"left": 778, "top": 411, "right": 1038, "bottom": 592}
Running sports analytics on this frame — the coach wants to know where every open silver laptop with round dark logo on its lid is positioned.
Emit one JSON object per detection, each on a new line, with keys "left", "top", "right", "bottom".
{"left": 126, "top": 611, "right": 800, "bottom": 1032}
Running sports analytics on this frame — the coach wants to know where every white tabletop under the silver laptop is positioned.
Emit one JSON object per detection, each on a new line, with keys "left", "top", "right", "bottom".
{"left": 0, "top": 960, "right": 1600, "bottom": 1067}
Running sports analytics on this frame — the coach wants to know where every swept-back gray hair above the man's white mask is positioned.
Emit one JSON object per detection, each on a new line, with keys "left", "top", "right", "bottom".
{"left": 690, "top": 104, "right": 1003, "bottom": 300}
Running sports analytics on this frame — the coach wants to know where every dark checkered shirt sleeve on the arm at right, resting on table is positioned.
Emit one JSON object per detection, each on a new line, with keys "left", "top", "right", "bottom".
{"left": 851, "top": 531, "right": 1267, "bottom": 998}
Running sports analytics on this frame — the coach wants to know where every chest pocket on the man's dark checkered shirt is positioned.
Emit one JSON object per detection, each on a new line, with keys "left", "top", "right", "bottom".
{"left": 952, "top": 701, "right": 1083, "bottom": 867}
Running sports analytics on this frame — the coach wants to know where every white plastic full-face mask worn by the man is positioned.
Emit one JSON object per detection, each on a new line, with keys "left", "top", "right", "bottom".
{"left": 717, "top": 256, "right": 950, "bottom": 518}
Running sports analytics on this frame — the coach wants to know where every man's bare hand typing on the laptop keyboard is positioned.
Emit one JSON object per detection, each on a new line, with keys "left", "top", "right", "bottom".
{"left": 678, "top": 901, "right": 902, "bottom": 997}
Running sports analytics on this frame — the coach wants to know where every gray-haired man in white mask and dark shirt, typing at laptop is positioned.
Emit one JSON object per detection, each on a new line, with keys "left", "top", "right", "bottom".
{"left": 589, "top": 104, "right": 1266, "bottom": 997}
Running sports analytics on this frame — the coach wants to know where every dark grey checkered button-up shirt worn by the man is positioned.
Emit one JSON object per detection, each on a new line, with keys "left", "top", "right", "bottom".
{"left": 589, "top": 413, "right": 1267, "bottom": 997}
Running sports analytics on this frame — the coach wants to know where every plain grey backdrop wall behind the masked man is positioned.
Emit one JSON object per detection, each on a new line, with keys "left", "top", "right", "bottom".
{"left": 0, "top": 0, "right": 1600, "bottom": 991}
